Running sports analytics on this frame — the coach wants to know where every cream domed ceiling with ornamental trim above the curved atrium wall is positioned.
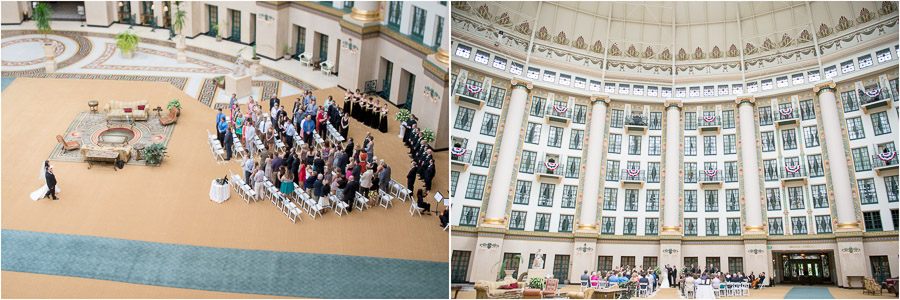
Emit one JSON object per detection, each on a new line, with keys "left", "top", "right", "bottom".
{"left": 453, "top": 1, "right": 897, "bottom": 63}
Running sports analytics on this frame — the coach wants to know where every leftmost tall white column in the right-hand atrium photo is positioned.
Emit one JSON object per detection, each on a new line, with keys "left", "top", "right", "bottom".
{"left": 482, "top": 78, "right": 531, "bottom": 227}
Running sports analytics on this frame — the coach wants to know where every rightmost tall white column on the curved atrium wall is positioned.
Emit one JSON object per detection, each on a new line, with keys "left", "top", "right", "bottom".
{"left": 813, "top": 81, "right": 859, "bottom": 230}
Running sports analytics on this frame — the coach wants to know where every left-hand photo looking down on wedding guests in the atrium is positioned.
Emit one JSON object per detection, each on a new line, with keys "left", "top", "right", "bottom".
{"left": 0, "top": 1, "right": 450, "bottom": 298}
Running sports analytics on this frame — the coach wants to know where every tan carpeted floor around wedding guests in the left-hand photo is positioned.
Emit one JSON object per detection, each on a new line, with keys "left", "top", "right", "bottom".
{"left": 0, "top": 78, "right": 449, "bottom": 297}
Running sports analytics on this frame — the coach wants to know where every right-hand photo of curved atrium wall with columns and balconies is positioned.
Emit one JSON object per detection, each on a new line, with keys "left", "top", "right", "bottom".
{"left": 450, "top": 1, "right": 900, "bottom": 299}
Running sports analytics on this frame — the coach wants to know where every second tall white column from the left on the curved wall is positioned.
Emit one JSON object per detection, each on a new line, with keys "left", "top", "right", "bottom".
{"left": 578, "top": 96, "right": 609, "bottom": 232}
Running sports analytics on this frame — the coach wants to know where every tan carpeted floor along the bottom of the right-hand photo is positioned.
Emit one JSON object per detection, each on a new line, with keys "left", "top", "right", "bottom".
{"left": 451, "top": 285, "right": 896, "bottom": 299}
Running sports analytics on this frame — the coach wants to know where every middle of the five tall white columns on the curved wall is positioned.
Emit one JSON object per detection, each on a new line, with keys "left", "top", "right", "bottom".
{"left": 663, "top": 100, "right": 682, "bottom": 234}
